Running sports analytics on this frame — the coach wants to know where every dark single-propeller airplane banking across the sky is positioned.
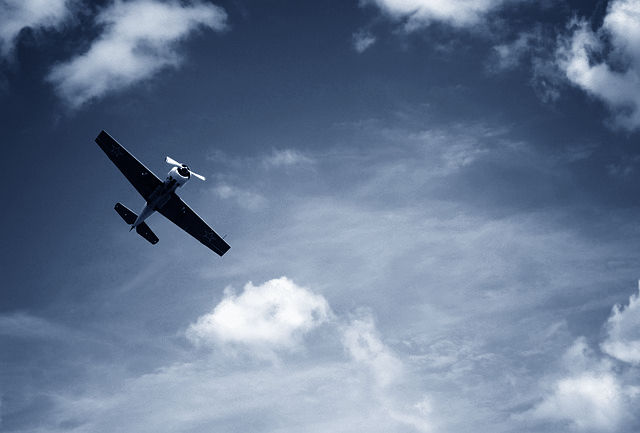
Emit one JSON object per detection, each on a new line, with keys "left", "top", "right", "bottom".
{"left": 96, "top": 131, "right": 231, "bottom": 256}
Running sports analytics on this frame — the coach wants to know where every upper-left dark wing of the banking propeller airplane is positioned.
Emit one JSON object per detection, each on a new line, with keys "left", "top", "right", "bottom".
{"left": 96, "top": 131, "right": 162, "bottom": 200}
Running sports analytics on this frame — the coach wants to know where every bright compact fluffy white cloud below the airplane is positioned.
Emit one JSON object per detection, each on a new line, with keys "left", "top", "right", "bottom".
{"left": 187, "top": 277, "right": 331, "bottom": 354}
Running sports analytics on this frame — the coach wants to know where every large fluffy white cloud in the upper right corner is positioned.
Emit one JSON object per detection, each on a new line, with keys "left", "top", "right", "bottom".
{"left": 557, "top": 0, "right": 640, "bottom": 130}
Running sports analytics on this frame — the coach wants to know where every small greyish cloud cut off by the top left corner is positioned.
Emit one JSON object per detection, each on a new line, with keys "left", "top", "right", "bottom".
{"left": 0, "top": 0, "right": 69, "bottom": 56}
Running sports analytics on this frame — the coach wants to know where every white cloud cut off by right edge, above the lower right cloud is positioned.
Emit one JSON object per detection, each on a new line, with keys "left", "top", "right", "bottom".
{"left": 601, "top": 282, "right": 640, "bottom": 364}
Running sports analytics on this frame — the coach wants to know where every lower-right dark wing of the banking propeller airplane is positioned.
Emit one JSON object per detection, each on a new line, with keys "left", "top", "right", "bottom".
{"left": 158, "top": 193, "right": 231, "bottom": 256}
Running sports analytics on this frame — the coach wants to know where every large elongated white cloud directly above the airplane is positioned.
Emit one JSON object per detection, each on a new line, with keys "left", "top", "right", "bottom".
{"left": 47, "top": 0, "right": 226, "bottom": 108}
